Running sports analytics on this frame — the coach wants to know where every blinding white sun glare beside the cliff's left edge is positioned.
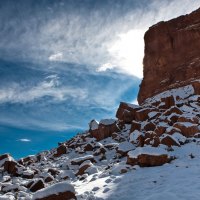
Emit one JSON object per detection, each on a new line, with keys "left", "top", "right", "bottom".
{"left": 108, "top": 29, "right": 145, "bottom": 78}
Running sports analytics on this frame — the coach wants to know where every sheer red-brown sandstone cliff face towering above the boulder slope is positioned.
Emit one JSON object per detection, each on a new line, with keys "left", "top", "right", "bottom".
{"left": 138, "top": 9, "right": 200, "bottom": 104}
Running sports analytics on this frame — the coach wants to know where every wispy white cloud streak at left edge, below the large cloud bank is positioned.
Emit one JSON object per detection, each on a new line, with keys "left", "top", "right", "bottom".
{"left": 0, "top": 76, "right": 87, "bottom": 103}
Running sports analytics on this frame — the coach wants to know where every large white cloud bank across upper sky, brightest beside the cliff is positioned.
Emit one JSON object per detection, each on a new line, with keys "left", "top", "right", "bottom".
{"left": 0, "top": 0, "right": 200, "bottom": 77}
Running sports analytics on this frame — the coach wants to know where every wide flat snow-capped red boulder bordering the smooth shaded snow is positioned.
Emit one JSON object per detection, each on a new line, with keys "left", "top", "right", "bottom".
{"left": 127, "top": 147, "right": 169, "bottom": 167}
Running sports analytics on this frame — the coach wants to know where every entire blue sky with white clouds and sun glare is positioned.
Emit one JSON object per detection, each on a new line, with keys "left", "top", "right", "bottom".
{"left": 0, "top": 0, "right": 200, "bottom": 157}
